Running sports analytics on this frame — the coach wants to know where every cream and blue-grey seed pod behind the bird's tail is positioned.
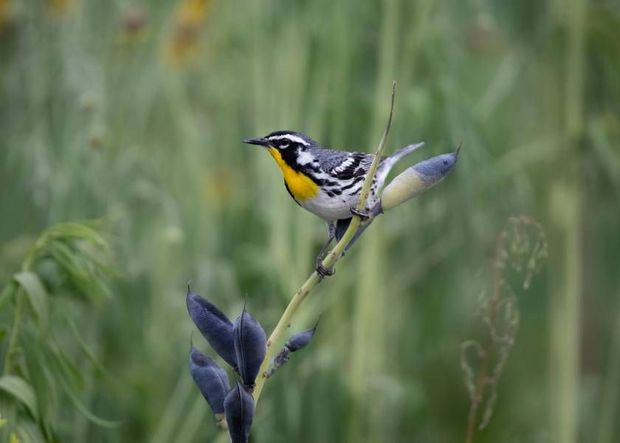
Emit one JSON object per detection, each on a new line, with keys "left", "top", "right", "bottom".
{"left": 381, "top": 150, "right": 458, "bottom": 211}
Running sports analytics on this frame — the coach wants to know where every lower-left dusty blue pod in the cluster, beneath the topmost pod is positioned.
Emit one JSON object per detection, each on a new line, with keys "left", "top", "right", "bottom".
{"left": 189, "top": 346, "right": 230, "bottom": 414}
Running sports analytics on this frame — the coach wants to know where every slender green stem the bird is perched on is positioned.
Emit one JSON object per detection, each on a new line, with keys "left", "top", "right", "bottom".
{"left": 253, "top": 82, "right": 396, "bottom": 403}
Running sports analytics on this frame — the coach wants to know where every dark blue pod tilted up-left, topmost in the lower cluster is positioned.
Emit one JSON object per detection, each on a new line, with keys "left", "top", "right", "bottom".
{"left": 186, "top": 286, "right": 237, "bottom": 370}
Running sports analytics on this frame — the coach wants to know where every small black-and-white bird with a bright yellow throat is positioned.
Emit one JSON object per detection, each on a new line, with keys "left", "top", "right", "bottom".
{"left": 244, "top": 131, "right": 424, "bottom": 275}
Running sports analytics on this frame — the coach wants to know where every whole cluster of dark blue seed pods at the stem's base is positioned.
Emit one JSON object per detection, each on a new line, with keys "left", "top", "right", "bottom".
{"left": 186, "top": 286, "right": 316, "bottom": 443}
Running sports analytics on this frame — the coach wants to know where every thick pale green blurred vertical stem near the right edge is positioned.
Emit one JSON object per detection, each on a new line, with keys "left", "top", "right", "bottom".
{"left": 549, "top": 0, "right": 588, "bottom": 443}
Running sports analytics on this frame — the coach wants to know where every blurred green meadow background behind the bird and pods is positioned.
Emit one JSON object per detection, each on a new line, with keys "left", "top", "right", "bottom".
{"left": 0, "top": 0, "right": 620, "bottom": 443}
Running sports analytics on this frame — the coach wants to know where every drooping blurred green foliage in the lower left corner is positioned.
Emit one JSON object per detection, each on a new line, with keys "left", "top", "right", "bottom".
{"left": 0, "top": 223, "right": 115, "bottom": 443}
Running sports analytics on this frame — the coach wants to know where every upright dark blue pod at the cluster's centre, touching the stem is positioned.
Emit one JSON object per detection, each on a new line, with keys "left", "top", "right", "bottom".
{"left": 233, "top": 307, "right": 267, "bottom": 389}
